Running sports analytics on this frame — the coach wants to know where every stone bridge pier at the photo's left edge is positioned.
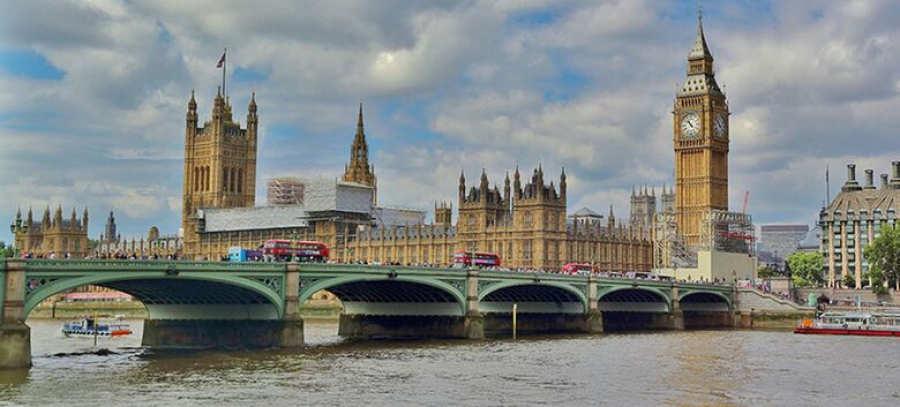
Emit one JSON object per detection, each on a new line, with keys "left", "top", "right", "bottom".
{"left": 0, "top": 259, "right": 31, "bottom": 369}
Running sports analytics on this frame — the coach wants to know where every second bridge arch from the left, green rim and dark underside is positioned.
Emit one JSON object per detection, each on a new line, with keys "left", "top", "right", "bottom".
{"left": 300, "top": 275, "right": 466, "bottom": 316}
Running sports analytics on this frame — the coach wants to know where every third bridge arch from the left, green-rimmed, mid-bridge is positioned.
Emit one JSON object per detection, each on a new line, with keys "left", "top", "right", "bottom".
{"left": 478, "top": 281, "right": 588, "bottom": 314}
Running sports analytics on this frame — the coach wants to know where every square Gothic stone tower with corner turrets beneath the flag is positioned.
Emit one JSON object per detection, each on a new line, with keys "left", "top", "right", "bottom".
{"left": 181, "top": 88, "right": 259, "bottom": 253}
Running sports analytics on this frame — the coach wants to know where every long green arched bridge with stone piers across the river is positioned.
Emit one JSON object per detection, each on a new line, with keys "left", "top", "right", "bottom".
{"left": 0, "top": 259, "right": 736, "bottom": 367}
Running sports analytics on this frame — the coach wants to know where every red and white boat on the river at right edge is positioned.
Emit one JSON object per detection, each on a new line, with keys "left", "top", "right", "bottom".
{"left": 794, "top": 312, "right": 900, "bottom": 337}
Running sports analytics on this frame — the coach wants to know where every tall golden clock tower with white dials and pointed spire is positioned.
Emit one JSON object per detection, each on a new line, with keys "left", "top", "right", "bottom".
{"left": 672, "top": 12, "right": 729, "bottom": 246}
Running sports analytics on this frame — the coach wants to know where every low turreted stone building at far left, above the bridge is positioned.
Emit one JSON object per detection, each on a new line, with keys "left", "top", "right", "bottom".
{"left": 10, "top": 207, "right": 90, "bottom": 258}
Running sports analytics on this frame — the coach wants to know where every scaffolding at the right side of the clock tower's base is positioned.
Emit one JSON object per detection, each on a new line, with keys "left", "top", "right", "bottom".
{"left": 700, "top": 210, "right": 756, "bottom": 256}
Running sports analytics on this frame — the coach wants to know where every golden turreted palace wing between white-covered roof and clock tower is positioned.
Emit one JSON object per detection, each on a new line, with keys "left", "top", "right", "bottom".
{"left": 350, "top": 167, "right": 652, "bottom": 271}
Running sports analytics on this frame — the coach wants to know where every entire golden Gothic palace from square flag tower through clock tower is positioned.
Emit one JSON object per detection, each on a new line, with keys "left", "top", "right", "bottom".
{"left": 12, "top": 15, "right": 729, "bottom": 271}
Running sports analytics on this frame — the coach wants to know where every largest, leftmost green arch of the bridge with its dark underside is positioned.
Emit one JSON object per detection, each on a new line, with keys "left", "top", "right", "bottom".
{"left": 23, "top": 272, "right": 284, "bottom": 320}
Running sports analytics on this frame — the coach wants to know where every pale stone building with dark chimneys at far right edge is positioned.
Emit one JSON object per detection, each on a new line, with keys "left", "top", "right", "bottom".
{"left": 819, "top": 161, "right": 900, "bottom": 288}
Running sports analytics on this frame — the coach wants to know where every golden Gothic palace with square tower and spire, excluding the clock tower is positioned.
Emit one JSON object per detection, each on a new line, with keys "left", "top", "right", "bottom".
{"left": 176, "top": 95, "right": 652, "bottom": 271}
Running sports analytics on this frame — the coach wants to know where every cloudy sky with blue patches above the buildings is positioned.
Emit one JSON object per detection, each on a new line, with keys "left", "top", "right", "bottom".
{"left": 0, "top": 0, "right": 900, "bottom": 245}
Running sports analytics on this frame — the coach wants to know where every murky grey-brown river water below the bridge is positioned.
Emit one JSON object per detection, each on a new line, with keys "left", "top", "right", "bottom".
{"left": 0, "top": 320, "right": 900, "bottom": 407}
